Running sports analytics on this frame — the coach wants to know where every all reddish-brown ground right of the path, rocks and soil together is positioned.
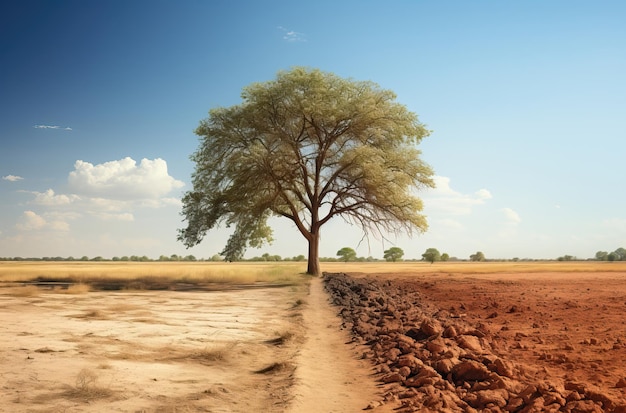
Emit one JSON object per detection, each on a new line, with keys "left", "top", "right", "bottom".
{"left": 324, "top": 273, "right": 626, "bottom": 413}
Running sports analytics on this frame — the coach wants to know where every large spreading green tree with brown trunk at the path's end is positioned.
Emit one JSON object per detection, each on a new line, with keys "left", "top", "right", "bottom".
{"left": 178, "top": 68, "right": 434, "bottom": 275}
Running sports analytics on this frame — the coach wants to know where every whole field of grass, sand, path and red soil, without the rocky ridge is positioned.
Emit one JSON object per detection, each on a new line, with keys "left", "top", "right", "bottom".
{"left": 0, "top": 262, "right": 626, "bottom": 413}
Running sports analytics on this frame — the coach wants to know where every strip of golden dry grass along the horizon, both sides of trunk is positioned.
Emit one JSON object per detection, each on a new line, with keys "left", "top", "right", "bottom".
{"left": 0, "top": 261, "right": 626, "bottom": 290}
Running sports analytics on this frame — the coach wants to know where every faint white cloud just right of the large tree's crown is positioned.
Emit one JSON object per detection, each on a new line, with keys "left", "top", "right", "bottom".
{"left": 422, "top": 176, "right": 493, "bottom": 215}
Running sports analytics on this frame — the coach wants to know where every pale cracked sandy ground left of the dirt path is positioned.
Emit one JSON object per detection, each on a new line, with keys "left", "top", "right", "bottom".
{"left": 0, "top": 286, "right": 305, "bottom": 413}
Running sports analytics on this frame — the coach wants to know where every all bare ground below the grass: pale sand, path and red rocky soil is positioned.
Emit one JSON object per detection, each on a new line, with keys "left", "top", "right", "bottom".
{"left": 0, "top": 272, "right": 626, "bottom": 413}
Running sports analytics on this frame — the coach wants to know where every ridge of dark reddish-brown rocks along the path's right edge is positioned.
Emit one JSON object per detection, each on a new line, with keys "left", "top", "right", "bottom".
{"left": 324, "top": 273, "right": 626, "bottom": 413}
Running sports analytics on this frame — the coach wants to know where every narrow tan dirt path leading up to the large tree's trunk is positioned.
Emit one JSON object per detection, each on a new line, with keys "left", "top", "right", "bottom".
{"left": 289, "top": 278, "right": 390, "bottom": 413}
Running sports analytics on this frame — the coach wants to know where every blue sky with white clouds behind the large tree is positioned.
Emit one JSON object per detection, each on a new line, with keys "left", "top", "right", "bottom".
{"left": 0, "top": 0, "right": 626, "bottom": 259}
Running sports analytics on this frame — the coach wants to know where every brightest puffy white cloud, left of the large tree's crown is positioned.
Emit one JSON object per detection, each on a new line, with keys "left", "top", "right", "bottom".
{"left": 68, "top": 157, "right": 185, "bottom": 200}
